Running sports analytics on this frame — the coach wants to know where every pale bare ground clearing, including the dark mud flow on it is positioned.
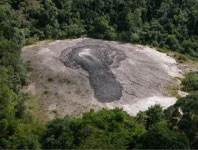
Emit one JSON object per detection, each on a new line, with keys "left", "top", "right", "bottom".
{"left": 22, "top": 38, "right": 186, "bottom": 120}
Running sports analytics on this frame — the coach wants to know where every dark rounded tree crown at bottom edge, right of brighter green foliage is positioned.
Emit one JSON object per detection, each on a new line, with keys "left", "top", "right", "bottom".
{"left": 140, "top": 122, "right": 189, "bottom": 149}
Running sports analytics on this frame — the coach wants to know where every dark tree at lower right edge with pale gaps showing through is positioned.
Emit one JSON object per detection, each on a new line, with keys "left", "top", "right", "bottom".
{"left": 165, "top": 94, "right": 198, "bottom": 149}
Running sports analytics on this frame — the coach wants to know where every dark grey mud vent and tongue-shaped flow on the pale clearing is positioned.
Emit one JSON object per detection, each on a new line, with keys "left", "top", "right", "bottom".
{"left": 61, "top": 45, "right": 125, "bottom": 102}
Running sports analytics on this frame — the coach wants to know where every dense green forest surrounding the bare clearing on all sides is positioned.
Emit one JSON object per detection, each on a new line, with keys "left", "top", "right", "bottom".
{"left": 0, "top": 0, "right": 198, "bottom": 149}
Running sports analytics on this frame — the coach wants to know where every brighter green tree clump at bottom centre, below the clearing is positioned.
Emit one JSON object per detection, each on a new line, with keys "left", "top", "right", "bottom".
{"left": 43, "top": 109, "right": 145, "bottom": 149}
